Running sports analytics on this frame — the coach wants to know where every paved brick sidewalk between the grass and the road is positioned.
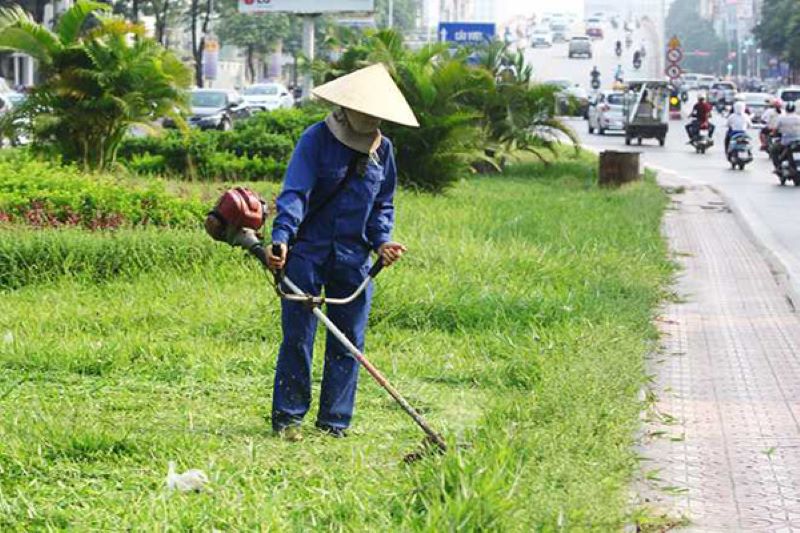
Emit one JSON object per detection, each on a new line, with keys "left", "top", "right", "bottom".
{"left": 641, "top": 178, "right": 800, "bottom": 532}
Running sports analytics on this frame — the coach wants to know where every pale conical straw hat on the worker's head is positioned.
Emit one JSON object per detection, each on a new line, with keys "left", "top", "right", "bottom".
{"left": 311, "top": 63, "right": 419, "bottom": 127}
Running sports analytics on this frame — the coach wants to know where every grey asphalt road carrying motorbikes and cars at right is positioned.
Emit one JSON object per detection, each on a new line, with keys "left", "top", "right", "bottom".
{"left": 526, "top": 25, "right": 800, "bottom": 295}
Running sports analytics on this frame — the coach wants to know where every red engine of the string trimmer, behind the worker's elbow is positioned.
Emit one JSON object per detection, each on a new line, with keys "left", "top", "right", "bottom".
{"left": 205, "top": 187, "right": 269, "bottom": 242}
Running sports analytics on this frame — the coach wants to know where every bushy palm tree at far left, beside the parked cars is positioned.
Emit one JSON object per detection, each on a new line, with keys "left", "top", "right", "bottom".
{"left": 0, "top": 0, "right": 191, "bottom": 169}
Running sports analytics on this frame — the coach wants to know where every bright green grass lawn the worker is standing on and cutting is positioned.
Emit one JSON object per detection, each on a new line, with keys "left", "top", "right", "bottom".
{"left": 0, "top": 154, "right": 671, "bottom": 531}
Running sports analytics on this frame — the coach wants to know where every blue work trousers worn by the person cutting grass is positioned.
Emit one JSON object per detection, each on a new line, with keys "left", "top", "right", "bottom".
{"left": 272, "top": 254, "right": 372, "bottom": 431}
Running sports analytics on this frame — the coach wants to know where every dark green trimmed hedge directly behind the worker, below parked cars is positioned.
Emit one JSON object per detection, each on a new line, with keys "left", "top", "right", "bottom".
{"left": 118, "top": 106, "right": 326, "bottom": 181}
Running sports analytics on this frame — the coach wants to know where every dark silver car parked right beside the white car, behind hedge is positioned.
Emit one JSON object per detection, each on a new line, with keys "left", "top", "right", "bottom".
{"left": 164, "top": 89, "right": 251, "bottom": 131}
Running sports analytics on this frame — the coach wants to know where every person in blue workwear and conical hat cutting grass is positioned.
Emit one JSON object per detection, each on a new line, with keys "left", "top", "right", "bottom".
{"left": 268, "top": 64, "right": 419, "bottom": 440}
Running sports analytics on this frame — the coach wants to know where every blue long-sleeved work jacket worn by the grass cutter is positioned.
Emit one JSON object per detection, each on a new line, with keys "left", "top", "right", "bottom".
{"left": 272, "top": 122, "right": 397, "bottom": 267}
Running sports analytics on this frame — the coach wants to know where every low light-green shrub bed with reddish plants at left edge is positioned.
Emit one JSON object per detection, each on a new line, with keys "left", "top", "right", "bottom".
{"left": 0, "top": 153, "right": 207, "bottom": 229}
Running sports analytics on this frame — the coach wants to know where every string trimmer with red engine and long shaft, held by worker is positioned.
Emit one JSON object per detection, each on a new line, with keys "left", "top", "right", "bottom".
{"left": 205, "top": 187, "right": 447, "bottom": 459}
